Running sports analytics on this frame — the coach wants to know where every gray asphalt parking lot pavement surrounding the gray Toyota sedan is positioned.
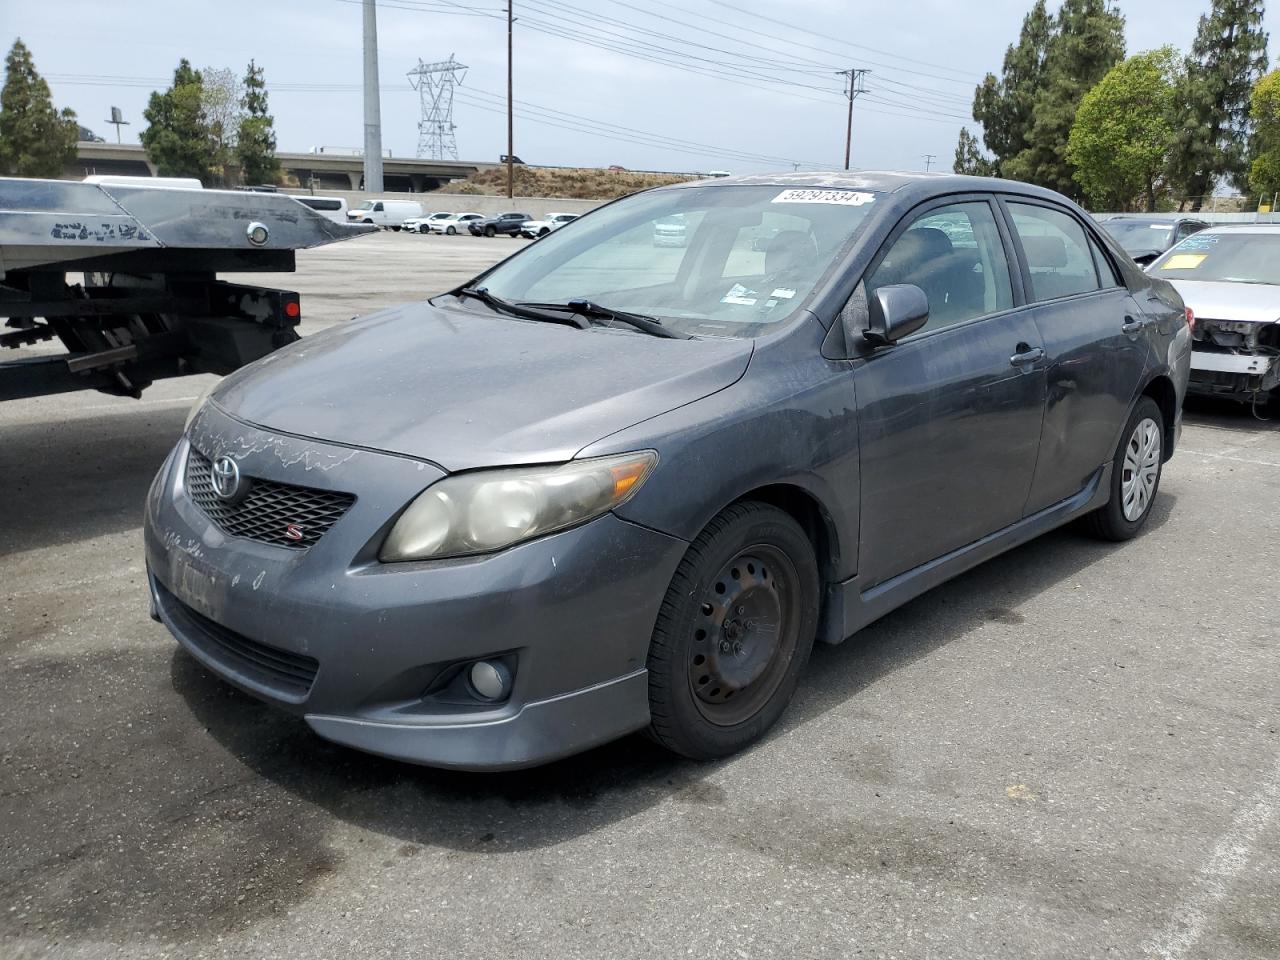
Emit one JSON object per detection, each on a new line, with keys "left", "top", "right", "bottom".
{"left": 0, "top": 234, "right": 1280, "bottom": 960}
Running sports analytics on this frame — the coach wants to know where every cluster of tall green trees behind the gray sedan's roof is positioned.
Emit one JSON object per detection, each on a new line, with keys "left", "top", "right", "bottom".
{"left": 955, "top": 0, "right": 1280, "bottom": 210}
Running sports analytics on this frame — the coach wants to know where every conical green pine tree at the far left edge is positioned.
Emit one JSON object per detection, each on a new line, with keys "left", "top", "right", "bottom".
{"left": 0, "top": 40, "right": 79, "bottom": 178}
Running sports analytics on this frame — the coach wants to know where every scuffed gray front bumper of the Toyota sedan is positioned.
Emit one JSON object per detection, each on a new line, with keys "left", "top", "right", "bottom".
{"left": 145, "top": 406, "right": 687, "bottom": 769}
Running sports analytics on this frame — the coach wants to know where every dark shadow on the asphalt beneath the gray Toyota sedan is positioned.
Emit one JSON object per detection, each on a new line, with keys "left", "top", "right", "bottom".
{"left": 172, "top": 494, "right": 1175, "bottom": 852}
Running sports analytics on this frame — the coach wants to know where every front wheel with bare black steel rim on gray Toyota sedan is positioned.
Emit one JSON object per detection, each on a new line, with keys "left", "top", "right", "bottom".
{"left": 648, "top": 502, "right": 819, "bottom": 760}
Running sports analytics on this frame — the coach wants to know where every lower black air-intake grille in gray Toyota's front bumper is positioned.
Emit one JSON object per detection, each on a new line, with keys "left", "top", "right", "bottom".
{"left": 155, "top": 581, "right": 320, "bottom": 700}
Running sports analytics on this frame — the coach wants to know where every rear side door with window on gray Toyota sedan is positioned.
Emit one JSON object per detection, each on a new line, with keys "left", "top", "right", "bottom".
{"left": 1002, "top": 197, "right": 1149, "bottom": 513}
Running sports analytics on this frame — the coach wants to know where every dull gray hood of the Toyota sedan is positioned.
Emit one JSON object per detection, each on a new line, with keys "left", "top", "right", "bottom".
{"left": 212, "top": 301, "right": 751, "bottom": 471}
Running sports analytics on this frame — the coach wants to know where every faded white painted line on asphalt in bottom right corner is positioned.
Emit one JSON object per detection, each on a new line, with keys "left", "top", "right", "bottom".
{"left": 1143, "top": 762, "right": 1280, "bottom": 960}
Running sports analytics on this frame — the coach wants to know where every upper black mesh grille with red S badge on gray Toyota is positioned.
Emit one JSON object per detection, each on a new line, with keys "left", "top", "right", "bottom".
{"left": 187, "top": 447, "right": 356, "bottom": 550}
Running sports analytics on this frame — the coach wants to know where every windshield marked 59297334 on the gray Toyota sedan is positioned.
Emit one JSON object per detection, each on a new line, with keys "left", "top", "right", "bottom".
{"left": 479, "top": 186, "right": 878, "bottom": 337}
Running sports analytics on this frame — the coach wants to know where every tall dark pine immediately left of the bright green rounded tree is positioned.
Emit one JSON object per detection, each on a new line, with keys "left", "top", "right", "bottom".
{"left": 1001, "top": 0, "right": 1124, "bottom": 193}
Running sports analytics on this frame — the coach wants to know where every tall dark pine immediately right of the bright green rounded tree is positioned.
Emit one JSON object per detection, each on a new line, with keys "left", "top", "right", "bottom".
{"left": 1175, "top": 0, "right": 1267, "bottom": 210}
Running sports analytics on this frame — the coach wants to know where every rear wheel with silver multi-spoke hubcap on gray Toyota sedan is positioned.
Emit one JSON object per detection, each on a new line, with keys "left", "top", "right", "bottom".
{"left": 1084, "top": 397, "right": 1165, "bottom": 541}
